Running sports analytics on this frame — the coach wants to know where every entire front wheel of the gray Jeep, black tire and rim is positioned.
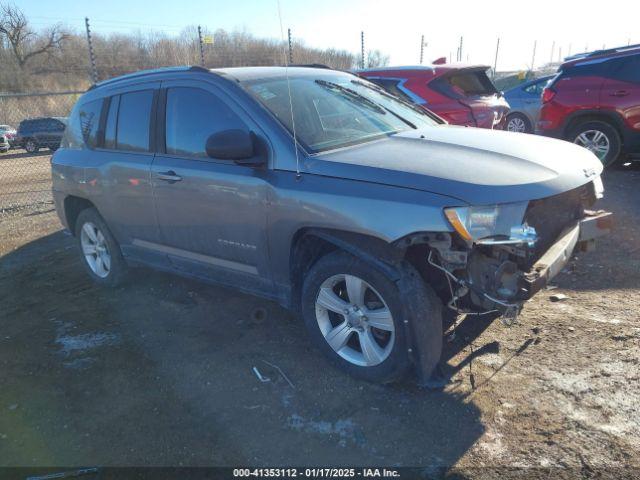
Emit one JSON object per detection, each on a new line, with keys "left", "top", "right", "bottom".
{"left": 302, "top": 251, "right": 411, "bottom": 383}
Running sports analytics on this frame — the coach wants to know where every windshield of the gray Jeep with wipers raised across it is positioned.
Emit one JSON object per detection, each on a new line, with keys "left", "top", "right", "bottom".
{"left": 247, "top": 75, "right": 440, "bottom": 153}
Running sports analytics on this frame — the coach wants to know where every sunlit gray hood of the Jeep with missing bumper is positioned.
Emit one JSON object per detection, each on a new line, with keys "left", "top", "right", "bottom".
{"left": 307, "top": 125, "right": 602, "bottom": 205}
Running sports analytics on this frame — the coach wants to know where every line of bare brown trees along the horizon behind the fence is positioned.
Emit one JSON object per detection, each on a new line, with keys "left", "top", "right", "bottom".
{"left": 0, "top": 4, "right": 389, "bottom": 92}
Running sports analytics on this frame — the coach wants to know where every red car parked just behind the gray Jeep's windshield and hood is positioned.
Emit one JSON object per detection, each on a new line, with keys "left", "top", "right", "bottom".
{"left": 357, "top": 64, "right": 509, "bottom": 129}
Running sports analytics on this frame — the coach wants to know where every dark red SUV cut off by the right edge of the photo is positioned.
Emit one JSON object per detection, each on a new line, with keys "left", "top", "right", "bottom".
{"left": 537, "top": 45, "right": 640, "bottom": 165}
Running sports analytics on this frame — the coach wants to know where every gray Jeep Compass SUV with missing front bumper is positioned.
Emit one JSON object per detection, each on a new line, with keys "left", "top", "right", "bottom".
{"left": 52, "top": 67, "right": 610, "bottom": 382}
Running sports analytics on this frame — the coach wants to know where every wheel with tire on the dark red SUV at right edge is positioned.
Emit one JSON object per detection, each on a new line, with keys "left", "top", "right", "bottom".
{"left": 567, "top": 120, "right": 622, "bottom": 167}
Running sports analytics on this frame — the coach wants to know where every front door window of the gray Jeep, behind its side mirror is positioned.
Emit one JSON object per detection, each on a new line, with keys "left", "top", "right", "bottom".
{"left": 166, "top": 87, "right": 247, "bottom": 158}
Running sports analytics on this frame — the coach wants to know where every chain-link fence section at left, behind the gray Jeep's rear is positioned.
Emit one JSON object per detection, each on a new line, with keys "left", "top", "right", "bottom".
{"left": 0, "top": 91, "right": 83, "bottom": 213}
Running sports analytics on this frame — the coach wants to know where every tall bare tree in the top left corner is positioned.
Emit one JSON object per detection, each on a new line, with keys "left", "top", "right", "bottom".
{"left": 0, "top": 4, "right": 69, "bottom": 69}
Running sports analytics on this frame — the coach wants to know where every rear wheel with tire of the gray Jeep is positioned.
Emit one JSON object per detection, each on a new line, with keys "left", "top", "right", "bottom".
{"left": 75, "top": 208, "right": 127, "bottom": 287}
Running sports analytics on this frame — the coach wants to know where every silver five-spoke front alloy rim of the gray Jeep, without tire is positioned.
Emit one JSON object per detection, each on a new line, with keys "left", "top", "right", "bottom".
{"left": 316, "top": 274, "right": 395, "bottom": 367}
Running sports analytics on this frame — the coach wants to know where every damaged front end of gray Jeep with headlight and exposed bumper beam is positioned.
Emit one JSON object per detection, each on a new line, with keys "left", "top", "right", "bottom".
{"left": 402, "top": 175, "right": 612, "bottom": 324}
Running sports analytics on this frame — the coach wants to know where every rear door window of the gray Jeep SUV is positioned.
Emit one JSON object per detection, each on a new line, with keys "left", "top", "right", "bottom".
{"left": 116, "top": 90, "right": 153, "bottom": 152}
